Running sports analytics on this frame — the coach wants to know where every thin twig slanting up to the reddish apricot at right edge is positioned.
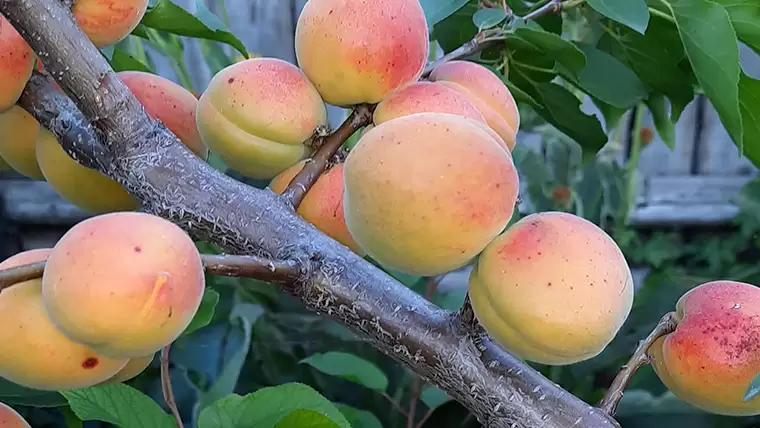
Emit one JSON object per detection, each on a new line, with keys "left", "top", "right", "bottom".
{"left": 597, "top": 312, "right": 678, "bottom": 416}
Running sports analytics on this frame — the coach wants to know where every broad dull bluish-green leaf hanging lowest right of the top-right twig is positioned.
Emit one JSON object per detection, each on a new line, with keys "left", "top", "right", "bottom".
{"left": 562, "top": 43, "right": 647, "bottom": 109}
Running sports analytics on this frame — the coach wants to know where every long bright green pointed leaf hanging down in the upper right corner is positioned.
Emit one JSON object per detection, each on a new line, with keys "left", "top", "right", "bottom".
{"left": 669, "top": 0, "right": 743, "bottom": 151}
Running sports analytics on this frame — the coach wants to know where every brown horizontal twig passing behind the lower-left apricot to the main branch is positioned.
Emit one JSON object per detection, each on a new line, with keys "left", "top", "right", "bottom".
{"left": 0, "top": 254, "right": 301, "bottom": 290}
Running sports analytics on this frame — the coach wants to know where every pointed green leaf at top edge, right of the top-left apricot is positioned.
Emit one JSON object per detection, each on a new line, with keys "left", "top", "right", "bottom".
{"left": 140, "top": 0, "right": 248, "bottom": 58}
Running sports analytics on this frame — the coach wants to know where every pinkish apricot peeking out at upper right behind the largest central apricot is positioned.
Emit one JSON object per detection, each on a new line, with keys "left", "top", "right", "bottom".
{"left": 429, "top": 60, "right": 520, "bottom": 148}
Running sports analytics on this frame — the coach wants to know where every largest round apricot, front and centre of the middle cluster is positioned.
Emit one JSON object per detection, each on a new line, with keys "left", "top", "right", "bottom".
{"left": 343, "top": 113, "right": 519, "bottom": 276}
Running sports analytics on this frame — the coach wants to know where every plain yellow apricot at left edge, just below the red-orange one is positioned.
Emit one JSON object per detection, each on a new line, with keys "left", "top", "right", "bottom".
{"left": 0, "top": 105, "right": 45, "bottom": 180}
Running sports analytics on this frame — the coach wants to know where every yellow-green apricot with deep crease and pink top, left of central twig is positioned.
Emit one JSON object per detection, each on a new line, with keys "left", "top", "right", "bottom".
{"left": 196, "top": 58, "right": 327, "bottom": 180}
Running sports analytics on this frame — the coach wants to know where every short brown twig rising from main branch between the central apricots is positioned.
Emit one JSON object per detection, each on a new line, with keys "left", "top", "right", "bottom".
{"left": 282, "top": 104, "right": 375, "bottom": 209}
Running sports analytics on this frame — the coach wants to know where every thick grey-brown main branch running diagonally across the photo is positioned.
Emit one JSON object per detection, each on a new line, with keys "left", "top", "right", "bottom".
{"left": 0, "top": 0, "right": 619, "bottom": 428}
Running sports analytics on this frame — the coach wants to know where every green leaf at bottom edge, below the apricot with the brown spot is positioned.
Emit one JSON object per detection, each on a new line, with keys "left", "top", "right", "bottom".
{"left": 61, "top": 383, "right": 176, "bottom": 428}
